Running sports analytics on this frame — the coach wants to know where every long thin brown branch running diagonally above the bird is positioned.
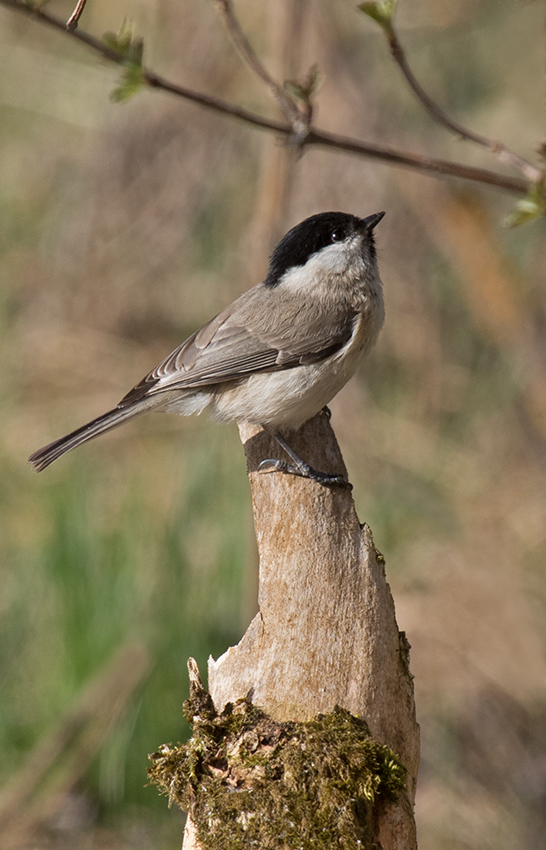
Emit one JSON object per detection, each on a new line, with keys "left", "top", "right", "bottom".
{"left": 0, "top": 0, "right": 529, "bottom": 195}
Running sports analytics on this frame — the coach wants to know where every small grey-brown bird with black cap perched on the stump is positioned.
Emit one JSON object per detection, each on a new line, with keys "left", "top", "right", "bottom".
{"left": 29, "top": 212, "right": 385, "bottom": 486}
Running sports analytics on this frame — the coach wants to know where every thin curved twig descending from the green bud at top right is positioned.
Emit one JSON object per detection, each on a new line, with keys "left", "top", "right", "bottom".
{"left": 385, "top": 23, "right": 544, "bottom": 183}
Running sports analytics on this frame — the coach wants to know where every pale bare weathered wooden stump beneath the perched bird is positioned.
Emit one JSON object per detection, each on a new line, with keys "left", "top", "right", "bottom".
{"left": 184, "top": 415, "right": 419, "bottom": 850}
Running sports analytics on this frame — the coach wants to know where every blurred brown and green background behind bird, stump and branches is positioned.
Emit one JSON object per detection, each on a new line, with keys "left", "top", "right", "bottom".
{"left": 0, "top": 0, "right": 546, "bottom": 850}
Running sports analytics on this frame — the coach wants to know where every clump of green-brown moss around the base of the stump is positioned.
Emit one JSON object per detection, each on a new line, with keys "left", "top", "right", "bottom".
{"left": 148, "top": 689, "right": 405, "bottom": 850}
